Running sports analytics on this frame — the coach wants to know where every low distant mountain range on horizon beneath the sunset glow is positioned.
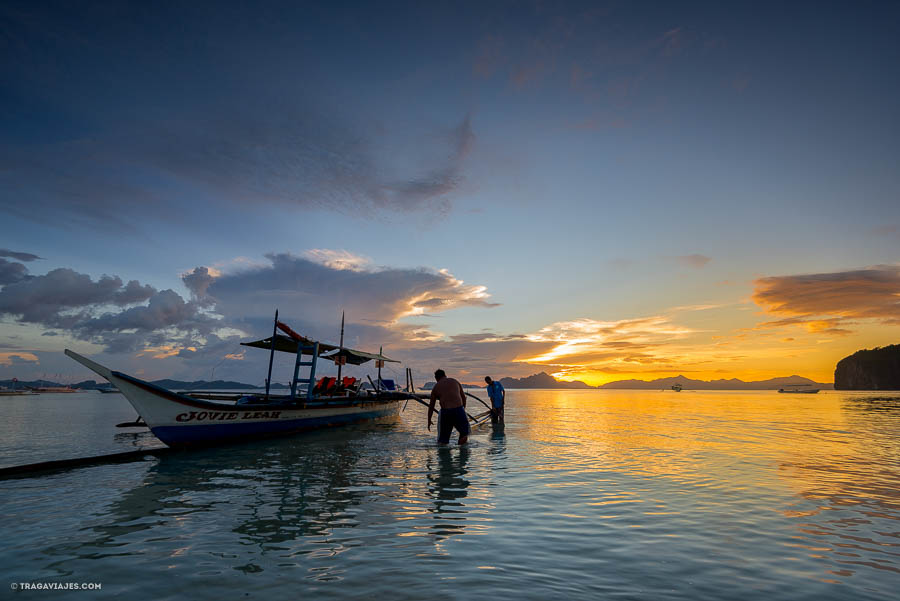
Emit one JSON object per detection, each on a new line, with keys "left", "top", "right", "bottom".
{"left": 492, "top": 372, "right": 832, "bottom": 390}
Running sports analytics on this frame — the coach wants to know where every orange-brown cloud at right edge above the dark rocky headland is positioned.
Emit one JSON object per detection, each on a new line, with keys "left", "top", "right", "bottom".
{"left": 752, "top": 265, "right": 900, "bottom": 334}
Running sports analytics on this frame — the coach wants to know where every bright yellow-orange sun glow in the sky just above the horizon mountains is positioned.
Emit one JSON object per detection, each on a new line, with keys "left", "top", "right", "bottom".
{"left": 516, "top": 311, "right": 885, "bottom": 386}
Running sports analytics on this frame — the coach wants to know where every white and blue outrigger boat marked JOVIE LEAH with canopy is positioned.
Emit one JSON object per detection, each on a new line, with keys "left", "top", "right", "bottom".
{"left": 65, "top": 311, "right": 496, "bottom": 447}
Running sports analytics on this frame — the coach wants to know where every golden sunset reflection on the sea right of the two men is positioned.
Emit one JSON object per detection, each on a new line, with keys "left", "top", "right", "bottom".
{"left": 519, "top": 391, "right": 900, "bottom": 583}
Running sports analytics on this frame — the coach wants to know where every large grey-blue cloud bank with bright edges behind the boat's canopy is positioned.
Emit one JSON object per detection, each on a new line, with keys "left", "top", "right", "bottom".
{"left": 0, "top": 249, "right": 506, "bottom": 367}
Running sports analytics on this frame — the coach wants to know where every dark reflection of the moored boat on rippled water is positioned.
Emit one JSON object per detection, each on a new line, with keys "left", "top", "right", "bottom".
{"left": 44, "top": 424, "right": 390, "bottom": 574}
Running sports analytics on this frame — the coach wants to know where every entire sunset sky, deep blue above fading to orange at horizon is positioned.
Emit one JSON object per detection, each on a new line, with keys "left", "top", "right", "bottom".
{"left": 0, "top": 0, "right": 900, "bottom": 384}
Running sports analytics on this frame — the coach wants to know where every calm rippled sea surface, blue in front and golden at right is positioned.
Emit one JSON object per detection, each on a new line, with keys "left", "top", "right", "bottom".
{"left": 0, "top": 391, "right": 900, "bottom": 600}
